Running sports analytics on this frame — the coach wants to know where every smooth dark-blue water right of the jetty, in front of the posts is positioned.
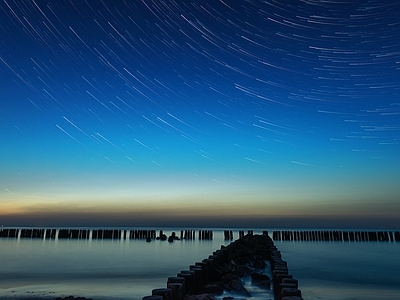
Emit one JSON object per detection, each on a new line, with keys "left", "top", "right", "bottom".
{"left": 275, "top": 241, "right": 400, "bottom": 300}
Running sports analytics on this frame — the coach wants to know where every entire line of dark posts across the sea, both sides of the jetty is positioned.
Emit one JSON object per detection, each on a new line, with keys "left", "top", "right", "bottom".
{"left": 0, "top": 228, "right": 400, "bottom": 242}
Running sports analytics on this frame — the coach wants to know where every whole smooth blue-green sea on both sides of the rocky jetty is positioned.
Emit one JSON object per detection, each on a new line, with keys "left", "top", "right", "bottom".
{"left": 0, "top": 227, "right": 400, "bottom": 300}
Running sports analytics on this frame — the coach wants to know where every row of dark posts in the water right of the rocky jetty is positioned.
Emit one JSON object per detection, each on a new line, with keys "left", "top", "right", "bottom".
{"left": 272, "top": 231, "right": 400, "bottom": 242}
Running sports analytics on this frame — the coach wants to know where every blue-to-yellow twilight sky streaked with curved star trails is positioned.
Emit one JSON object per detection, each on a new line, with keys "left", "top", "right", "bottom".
{"left": 0, "top": 0, "right": 400, "bottom": 228}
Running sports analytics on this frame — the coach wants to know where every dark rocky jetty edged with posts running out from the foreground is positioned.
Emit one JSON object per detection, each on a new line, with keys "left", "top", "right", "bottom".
{"left": 142, "top": 231, "right": 303, "bottom": 300}
